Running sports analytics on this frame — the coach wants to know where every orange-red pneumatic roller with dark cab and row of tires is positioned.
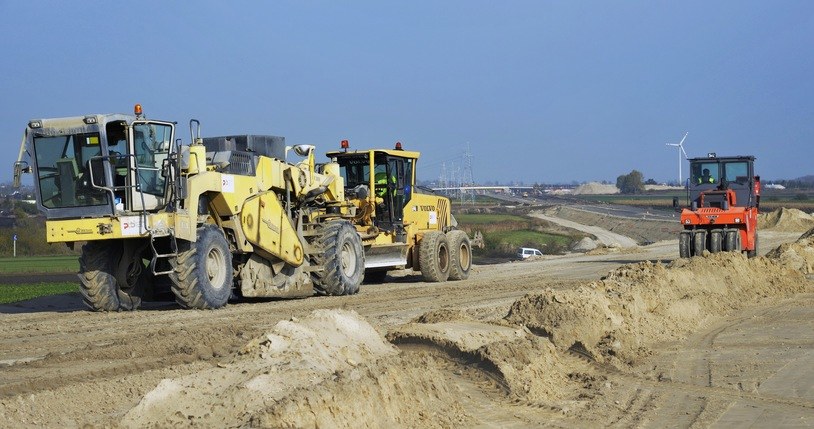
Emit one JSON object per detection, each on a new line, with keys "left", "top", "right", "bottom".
{"left": 679, "top": 153, "right": 760, "bottom": 258}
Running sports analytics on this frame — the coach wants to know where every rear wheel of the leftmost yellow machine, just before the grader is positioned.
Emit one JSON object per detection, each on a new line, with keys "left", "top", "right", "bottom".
{"left": 309, "top": 220, "right": 365, "bottom": 295}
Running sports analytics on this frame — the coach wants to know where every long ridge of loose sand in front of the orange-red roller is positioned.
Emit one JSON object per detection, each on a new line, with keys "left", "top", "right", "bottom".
{"left": 506, "top": 253, "right": 805, "bottom": 366}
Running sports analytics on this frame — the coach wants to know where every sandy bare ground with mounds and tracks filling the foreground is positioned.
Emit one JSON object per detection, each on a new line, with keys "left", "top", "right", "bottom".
{"left": 0, "top": 209, "right": 814, "bottom": 427}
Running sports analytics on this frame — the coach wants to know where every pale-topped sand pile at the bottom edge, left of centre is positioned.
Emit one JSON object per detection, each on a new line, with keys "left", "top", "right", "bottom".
{"left": 121, "top": 310, "right": 463, "bottom": 427}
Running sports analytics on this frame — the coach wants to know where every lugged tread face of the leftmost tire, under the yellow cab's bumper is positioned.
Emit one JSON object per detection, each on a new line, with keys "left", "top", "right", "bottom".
{"left": 77, "top": 241, "right": 126, "bottom": 311}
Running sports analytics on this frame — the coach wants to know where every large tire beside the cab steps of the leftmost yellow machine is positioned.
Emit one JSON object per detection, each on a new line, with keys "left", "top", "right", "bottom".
{"left": 170, "top": 225, "right": 233, "bottom": 309}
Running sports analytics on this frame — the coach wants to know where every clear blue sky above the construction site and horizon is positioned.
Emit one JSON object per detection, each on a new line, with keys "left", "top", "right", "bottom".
{"left": 0, "top": 0, "right": 814, "bottom": 183}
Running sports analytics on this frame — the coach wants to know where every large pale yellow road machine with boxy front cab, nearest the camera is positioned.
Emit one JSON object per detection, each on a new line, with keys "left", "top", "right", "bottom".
{"left": 14, "top": 105, "right": 364, "bottom": 311}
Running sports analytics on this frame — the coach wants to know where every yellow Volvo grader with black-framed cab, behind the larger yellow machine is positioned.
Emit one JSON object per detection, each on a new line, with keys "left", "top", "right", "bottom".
{"left": 327, "top": 140, "right": 472, "bottom": 282}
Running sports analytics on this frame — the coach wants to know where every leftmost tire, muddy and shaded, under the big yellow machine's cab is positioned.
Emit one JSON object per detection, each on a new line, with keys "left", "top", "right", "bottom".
{"left": 78, "top": 240, "right": 144, "bottom": 311}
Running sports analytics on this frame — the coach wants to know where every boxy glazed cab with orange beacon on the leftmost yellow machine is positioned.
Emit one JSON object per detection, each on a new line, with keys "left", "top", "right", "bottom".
{"left": 15, "top": 114, "right": 175, "bottom": 219}
